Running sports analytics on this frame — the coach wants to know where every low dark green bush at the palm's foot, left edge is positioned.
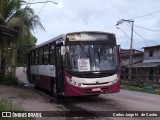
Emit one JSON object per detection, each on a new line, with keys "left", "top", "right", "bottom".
{"left": 0, "top": 73, "right": 18, "bottom": 86}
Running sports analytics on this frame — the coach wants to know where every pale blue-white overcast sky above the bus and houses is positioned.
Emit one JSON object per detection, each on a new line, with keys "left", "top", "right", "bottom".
{"left": 27, "top": 0, "right": 160, "bottom": 50}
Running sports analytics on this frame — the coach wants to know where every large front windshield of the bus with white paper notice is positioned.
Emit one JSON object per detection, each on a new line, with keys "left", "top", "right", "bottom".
{"left": 65, "top": 43, "right": 117, "bottom": 72}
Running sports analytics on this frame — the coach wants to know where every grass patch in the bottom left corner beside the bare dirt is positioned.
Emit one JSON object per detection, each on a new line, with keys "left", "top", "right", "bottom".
{"left": 0, "top": 99, "right": 32, "bottom": 120}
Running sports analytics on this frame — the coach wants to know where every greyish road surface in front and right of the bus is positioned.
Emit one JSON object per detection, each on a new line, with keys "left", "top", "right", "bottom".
{"left": 14, "top": 67, "right": 160, "bottom": 120}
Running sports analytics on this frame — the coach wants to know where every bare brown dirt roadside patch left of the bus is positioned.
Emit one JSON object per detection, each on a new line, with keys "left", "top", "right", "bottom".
{"left": 0, "top": 85, "right": 66, "bottom": 120}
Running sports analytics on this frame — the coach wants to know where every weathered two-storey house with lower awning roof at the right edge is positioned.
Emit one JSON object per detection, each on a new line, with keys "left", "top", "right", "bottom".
{"left": 129, "top": 45, "right": 160, "bottom": 83}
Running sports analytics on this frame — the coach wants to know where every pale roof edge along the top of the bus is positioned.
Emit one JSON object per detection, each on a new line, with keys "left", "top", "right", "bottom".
{"left": 29, "top": 31, "right": 115, "bottom": 51}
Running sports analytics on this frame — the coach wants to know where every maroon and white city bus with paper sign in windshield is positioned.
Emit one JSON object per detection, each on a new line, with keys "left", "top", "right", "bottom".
{"left": 27, "top": 31, "right": 120, "bottom": 98}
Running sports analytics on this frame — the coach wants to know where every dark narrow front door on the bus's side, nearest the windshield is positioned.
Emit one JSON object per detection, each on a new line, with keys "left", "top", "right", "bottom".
{"left": 56, "top": 46, "right": 64, "bottom": 95}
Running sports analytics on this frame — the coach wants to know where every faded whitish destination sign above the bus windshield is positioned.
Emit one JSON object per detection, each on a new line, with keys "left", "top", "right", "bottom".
{"left": 67, "top": 33, "right": 109, "bottom": 41}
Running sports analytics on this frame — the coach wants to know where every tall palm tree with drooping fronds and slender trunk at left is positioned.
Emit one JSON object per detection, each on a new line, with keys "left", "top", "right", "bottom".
{"left": 0, "top": 0, "right": 44, "bottom": 76}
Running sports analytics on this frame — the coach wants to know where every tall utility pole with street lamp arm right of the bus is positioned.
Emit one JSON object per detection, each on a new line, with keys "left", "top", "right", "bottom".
{"left": 116, "top": 19, "right": 134, "bottom": 65}
